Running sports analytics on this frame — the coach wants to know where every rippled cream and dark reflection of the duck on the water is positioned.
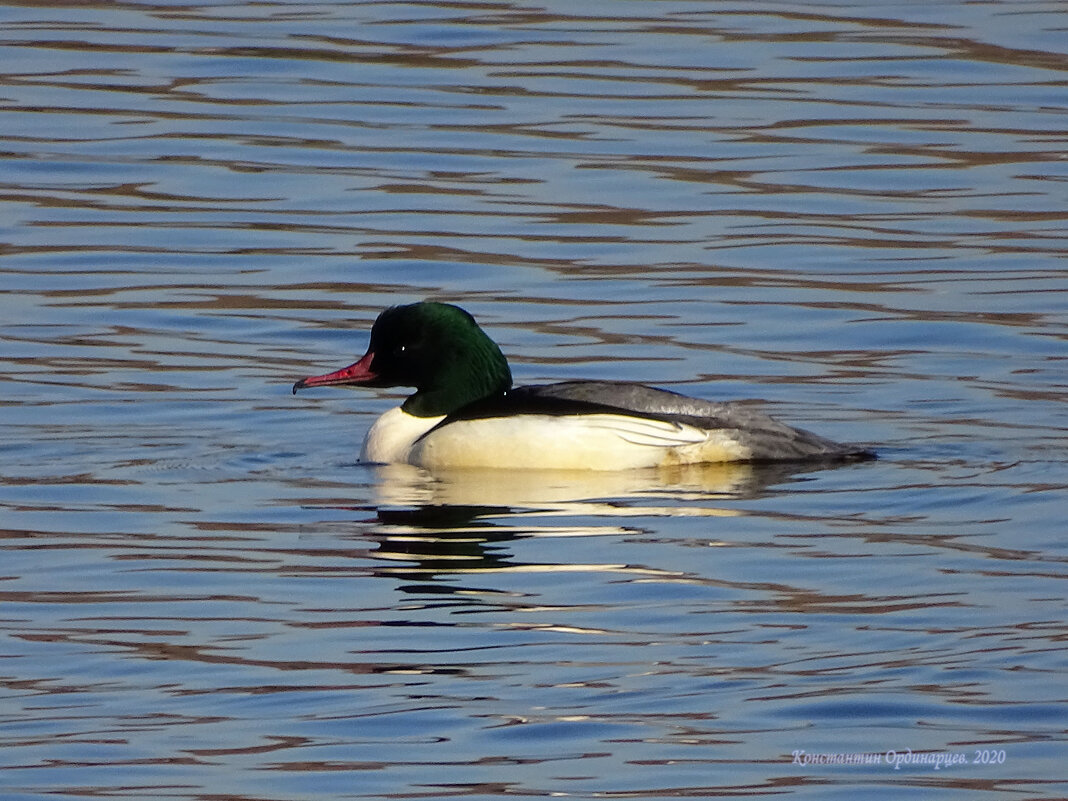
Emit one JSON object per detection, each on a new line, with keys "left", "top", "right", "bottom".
{"left": 356, "top": 464, "right": 818, "bottom": 593}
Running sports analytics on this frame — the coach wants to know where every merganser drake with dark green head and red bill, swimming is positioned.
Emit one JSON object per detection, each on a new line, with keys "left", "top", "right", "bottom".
{"left": 293, "top": 302, "right": 874, "bottom": 470}
